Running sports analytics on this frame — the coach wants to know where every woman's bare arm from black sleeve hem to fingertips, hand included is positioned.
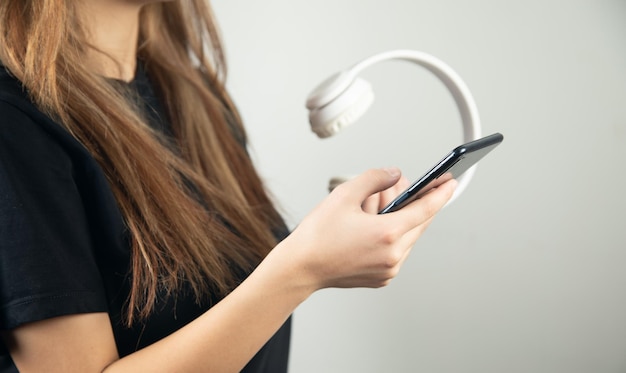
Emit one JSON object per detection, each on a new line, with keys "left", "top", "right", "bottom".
{"left": 3, "top": 171, "right": 455, "bottom": 372}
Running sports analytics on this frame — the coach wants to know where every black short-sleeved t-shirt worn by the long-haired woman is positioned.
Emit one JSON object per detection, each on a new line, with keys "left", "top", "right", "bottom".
{"left": 0, "top": 66, "right": 290, "bottom": 373}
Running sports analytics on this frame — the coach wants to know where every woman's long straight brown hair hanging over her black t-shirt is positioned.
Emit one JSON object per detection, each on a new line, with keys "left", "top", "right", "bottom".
{"left": 0, "top": 0, "right": 281, "bottom": 325}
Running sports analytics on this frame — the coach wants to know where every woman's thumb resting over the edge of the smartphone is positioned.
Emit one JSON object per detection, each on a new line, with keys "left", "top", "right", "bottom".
{"left": 335, "top": 167, "right": 402, "bottom": 204}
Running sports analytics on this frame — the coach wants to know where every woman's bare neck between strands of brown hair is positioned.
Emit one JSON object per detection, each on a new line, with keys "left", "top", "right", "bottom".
{"left": 82, "top": 0, "right": 141, "bottom": 81}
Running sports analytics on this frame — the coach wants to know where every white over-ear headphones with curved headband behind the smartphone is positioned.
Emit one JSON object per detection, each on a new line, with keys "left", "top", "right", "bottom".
{"left": 306, "top": 49, "right": 481, "bottom": 203}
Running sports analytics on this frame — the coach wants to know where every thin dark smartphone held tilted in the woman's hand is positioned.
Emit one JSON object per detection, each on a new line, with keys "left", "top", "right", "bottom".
{"left": 379, "top": 133, "right": 504, "bottom": 214}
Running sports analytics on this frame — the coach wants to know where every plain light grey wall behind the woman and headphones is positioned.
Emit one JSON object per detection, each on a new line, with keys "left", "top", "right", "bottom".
{"left": 213, "top": 0, "right": 626, "bottom": 373}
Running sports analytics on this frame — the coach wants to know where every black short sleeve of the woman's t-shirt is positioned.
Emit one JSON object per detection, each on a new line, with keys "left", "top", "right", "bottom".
{"left": 0, "top": 100, "right": 107, "bottom": 330}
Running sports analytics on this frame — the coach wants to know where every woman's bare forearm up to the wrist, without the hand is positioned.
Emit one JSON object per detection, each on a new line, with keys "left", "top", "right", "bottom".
{"left": 105, "top": 241, "right": 314, "bottom": 372}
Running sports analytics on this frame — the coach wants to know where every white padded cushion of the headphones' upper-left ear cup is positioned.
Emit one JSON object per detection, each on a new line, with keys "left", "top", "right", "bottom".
{"left": 309, "top": 77, "right": 374, "bottom": 138}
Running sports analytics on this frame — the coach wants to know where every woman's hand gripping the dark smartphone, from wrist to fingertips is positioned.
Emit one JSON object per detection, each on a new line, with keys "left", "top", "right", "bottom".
{"left": 273, "top": 168, "right": 456, "bottom": 291}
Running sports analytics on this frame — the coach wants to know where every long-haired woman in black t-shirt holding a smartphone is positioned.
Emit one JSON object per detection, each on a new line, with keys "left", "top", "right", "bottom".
{"left": 0, "top": 0, "right": 455, "bottom": 373}
